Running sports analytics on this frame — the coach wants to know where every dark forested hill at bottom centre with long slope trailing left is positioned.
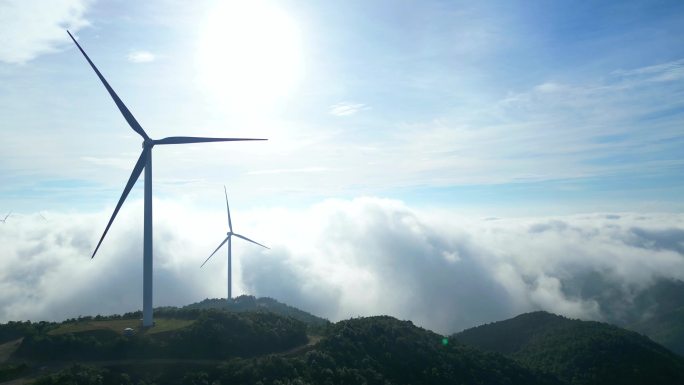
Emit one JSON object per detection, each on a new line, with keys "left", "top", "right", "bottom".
{"left": 26, "top": 316, "right": 560, "bottom": 385}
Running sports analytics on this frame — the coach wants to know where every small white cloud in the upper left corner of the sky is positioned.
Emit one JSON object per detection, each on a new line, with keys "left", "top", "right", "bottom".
{"left": 0, "top": 0, "right": 92, "bottom": 64}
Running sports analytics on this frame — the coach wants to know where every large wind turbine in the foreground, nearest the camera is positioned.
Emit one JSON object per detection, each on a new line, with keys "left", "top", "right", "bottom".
{"left": 67, "top": 31, "right": 266, "bottom": 327}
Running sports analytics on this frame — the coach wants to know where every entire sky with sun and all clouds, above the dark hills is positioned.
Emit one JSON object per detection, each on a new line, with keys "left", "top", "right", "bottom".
{"left": 0, "top": 0, "right": 684, "bottom": 333}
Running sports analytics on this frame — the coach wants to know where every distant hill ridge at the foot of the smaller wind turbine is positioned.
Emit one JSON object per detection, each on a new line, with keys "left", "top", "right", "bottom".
{"left": 182, "top": 295, "right": 330, "bottom": 328}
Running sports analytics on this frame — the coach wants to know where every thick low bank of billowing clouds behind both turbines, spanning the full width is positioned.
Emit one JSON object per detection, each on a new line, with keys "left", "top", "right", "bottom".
{"left": 0, "top": 198, "right": 684, "bottom": 333}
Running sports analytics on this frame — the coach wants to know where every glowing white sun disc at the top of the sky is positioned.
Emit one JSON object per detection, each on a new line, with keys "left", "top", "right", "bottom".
{"left": 197, "top": 1, "right": 303, "bottom": 111}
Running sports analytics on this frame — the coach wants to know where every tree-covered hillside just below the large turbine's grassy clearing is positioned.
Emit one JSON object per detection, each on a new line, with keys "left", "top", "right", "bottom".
{"left": 13, "top": 309, "right": 308, "bottom": 362}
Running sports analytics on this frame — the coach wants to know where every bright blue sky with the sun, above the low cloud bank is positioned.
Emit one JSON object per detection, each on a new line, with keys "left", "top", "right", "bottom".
{"left": 0, "top": 0, "right": 684, "bottom": 213}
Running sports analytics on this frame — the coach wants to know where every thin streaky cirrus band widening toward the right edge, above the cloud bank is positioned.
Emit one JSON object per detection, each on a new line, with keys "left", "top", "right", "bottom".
{"left": 380, "top": 56, "right": 684, "bottom": 185}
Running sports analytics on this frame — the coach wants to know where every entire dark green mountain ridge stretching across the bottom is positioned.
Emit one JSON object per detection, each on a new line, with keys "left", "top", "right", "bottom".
{"left": 0, "top": 296, "right": 684, "bottom": 385}
